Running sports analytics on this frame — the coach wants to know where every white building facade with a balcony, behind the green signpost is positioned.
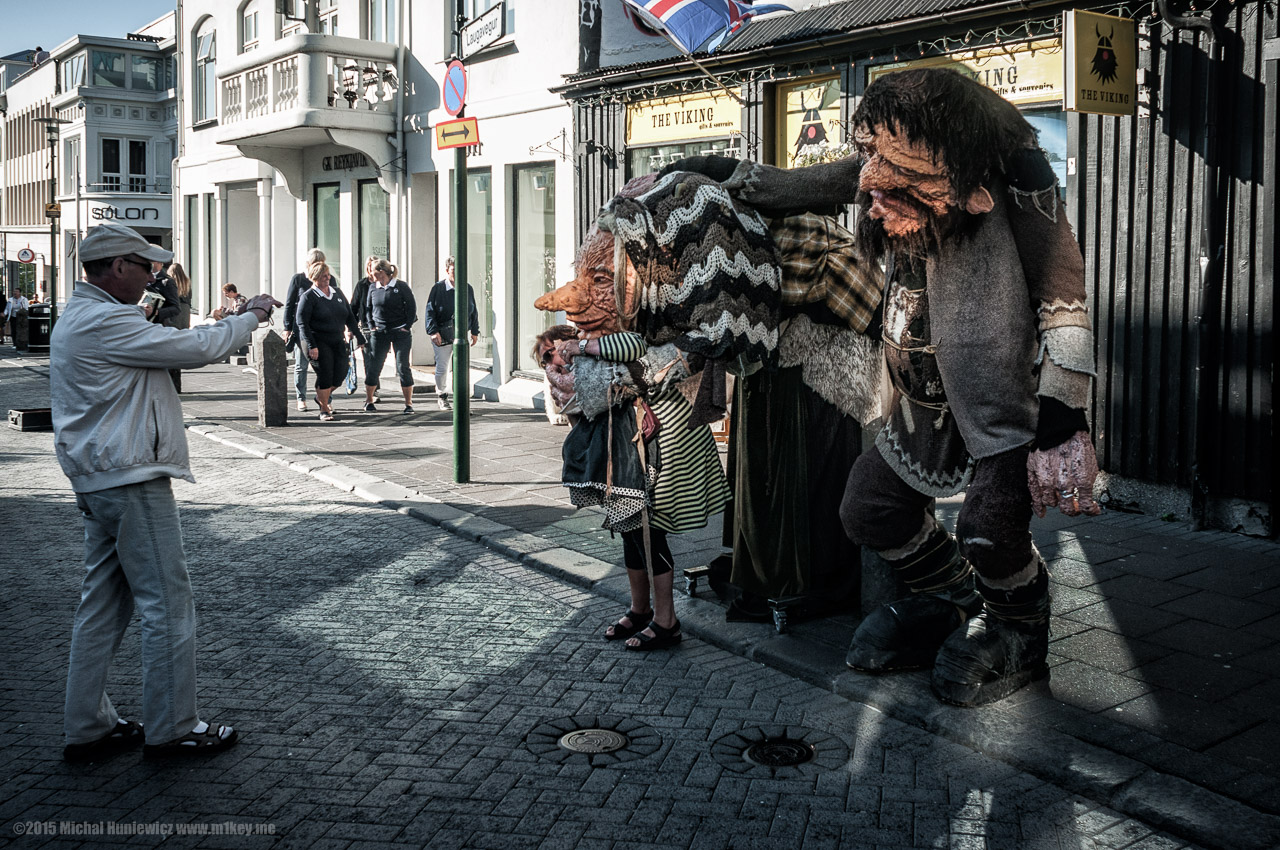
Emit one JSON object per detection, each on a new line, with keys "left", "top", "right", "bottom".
{"left": 174, "top": 0, "right": 577, "bottom": 402}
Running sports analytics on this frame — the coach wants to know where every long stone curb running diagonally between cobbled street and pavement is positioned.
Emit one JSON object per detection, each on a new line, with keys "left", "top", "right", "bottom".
{"left": 187, "top": 420, "right": 1280, "bottom": 850}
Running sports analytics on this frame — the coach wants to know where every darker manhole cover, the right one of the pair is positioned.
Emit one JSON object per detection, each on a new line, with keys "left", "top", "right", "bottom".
{"left": 712, "top": 726, "right": 849, "bottom": 778}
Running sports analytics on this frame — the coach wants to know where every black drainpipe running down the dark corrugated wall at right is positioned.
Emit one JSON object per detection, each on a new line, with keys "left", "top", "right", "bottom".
{"left": 1157, "top": 0, "right": 1226, "bottom": 529}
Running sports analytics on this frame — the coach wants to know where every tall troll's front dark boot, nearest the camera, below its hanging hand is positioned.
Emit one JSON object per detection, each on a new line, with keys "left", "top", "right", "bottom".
{"left": 933, "top": 565, "right": 1050, "bottom": 707}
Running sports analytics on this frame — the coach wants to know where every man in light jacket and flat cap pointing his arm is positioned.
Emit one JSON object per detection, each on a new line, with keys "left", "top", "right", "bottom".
{"left": 50, "top": 224, "right": 279, "bottom": 762}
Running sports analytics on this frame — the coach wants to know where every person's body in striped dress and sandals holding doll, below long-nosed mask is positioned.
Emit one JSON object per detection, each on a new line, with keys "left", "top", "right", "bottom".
{"left": 535, "top": 326, "right": 730, "bottom": 652}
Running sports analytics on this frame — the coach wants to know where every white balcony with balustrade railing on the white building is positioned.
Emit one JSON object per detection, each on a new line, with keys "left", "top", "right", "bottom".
{"left": 215, "top": 33, "right": 402, "bottom": 195}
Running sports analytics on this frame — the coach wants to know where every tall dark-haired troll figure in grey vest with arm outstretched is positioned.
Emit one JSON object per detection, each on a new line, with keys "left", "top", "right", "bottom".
{"left": 676, "top": 69, "right": 1100, "bottom": 705}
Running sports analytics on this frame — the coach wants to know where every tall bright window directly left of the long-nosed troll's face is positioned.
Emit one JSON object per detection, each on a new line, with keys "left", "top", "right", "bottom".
{"left": 512, "top": 163, "right": 556, "bottom": 371}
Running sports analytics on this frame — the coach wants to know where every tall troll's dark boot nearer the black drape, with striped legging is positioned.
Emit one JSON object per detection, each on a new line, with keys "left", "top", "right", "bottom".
{"left": 845, "top": 527, "right": 982, "bottom": 673}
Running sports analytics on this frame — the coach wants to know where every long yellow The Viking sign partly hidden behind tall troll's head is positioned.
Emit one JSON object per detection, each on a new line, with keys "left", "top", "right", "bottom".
{"left": 867, "top": 38, "right": 1064, "bottom": 106}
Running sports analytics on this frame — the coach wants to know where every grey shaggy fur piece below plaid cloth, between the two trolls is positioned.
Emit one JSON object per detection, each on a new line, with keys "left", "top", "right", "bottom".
{"left": 778, "top": 315, "right": 884, "bottom": 425}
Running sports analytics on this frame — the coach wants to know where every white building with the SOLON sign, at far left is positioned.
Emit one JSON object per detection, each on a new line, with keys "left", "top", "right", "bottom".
{"left": 0, "top": 14, "right": 178, "bottom": 301}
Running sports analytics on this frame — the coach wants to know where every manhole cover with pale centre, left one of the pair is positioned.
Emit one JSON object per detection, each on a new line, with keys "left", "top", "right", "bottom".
{"left": 525, "top": 714, "right": 662, "bottom": 767}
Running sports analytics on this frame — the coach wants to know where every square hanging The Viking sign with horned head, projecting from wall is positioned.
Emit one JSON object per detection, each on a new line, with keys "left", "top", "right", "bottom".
{"left": 1064, "top": 12, "right": 1138, "bottom": 115}
